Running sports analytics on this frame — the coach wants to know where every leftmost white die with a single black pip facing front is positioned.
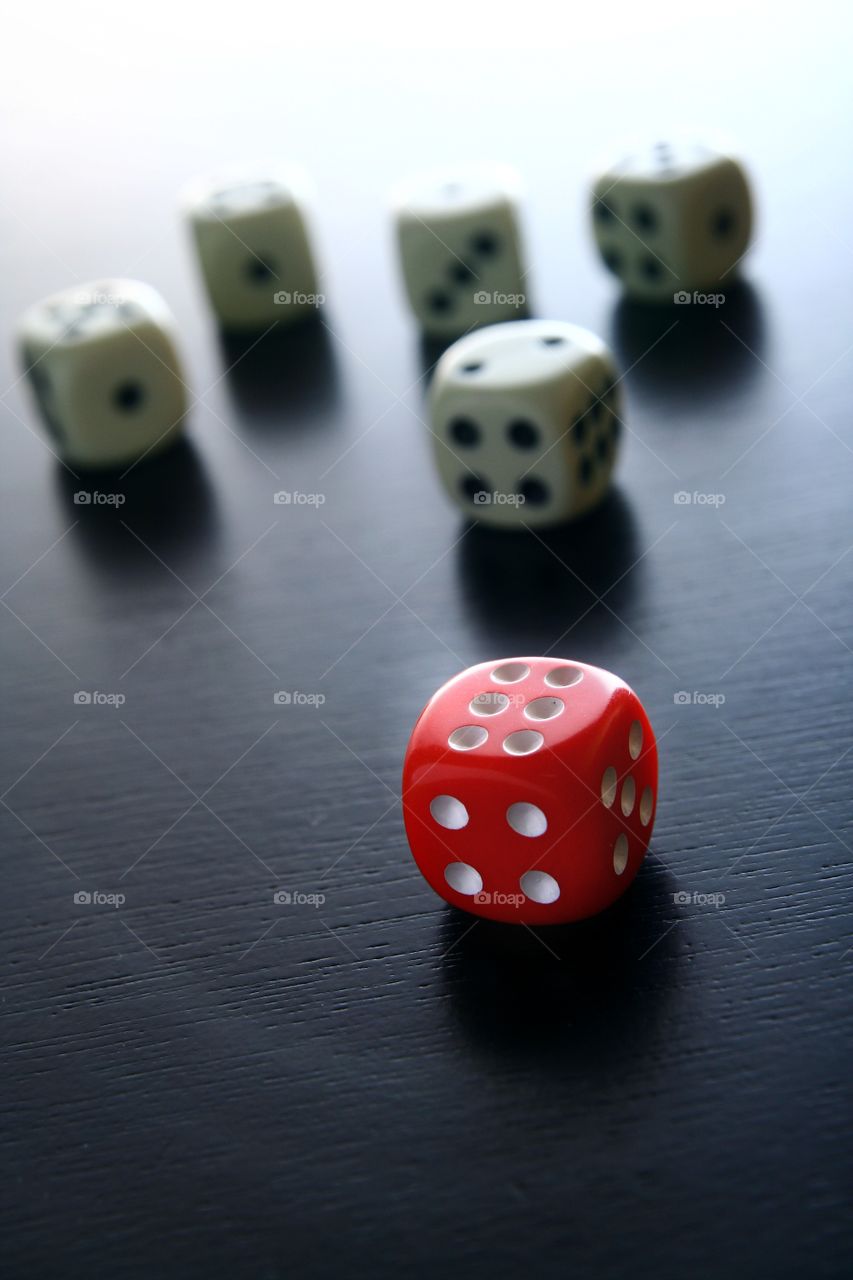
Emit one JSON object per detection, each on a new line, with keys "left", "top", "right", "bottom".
{"left": 18, "top": 279, "right": 187, "bottom": 467}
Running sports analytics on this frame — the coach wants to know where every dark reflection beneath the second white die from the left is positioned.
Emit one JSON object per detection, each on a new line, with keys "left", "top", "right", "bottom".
{"left": 219, "top": 316, "right": 341, "bottom": 433}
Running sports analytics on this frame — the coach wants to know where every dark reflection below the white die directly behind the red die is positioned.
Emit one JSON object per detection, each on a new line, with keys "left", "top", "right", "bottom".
{"left": 457, "top": 488, "right": 643, "bottom": 653}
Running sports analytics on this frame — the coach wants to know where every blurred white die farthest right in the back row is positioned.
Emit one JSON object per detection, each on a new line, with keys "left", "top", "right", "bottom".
{"left": 592, "top": 142, "right": 752, "bottom": 302}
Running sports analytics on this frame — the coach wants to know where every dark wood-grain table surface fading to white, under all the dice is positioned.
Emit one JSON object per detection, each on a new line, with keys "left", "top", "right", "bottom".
{"left": 0, "top": 4, "right": 853, "bottom": 1280}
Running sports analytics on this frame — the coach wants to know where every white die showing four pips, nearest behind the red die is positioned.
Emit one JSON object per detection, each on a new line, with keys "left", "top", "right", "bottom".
{"left": 429, "top": 320, "right": 621, "bottom": 527}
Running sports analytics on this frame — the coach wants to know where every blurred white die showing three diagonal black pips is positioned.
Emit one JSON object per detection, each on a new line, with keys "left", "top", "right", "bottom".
{"left": 394, "top": 169, "right": 526, "bottom": 338}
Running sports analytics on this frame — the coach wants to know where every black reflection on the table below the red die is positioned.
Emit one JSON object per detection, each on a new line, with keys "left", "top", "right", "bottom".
{"left": 438, "top": 852, "right": 686, "bottom": 1070}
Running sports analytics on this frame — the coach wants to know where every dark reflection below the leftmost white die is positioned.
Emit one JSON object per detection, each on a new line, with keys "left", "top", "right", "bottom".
{"left": 55, "top": 438, "right": 219, "bottom": 576}
